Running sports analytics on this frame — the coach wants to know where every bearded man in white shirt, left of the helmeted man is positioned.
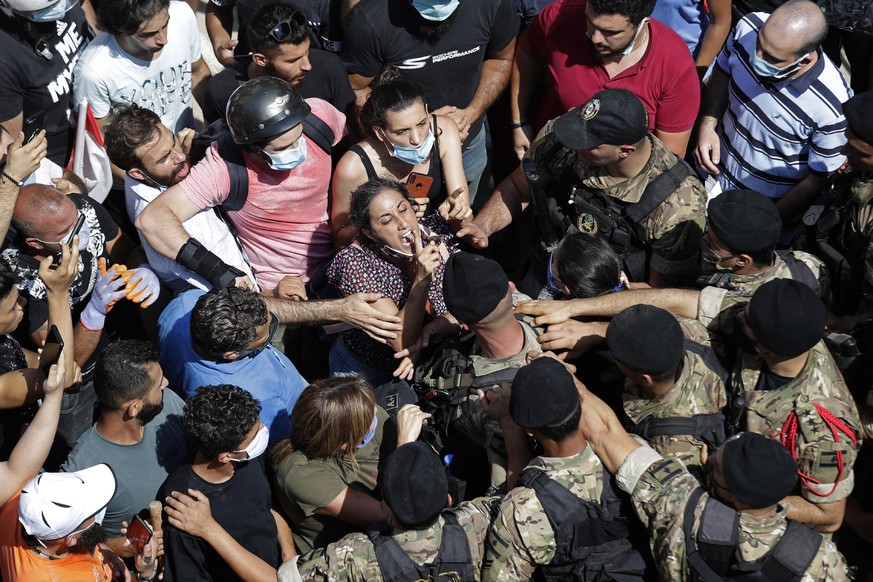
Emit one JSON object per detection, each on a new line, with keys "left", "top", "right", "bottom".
{"left": 105, "top": 105, "right": 255, "bottom": 293}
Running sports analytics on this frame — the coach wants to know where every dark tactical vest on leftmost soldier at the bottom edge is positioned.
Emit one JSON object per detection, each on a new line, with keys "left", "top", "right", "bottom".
{"left": 367, "top": 510, "right": 475, "bottom": 582}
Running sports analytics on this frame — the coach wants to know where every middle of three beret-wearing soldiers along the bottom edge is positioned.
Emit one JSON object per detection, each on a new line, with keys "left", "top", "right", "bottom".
{"left": 482, "top": 357, "right": 645, "bottom": 582}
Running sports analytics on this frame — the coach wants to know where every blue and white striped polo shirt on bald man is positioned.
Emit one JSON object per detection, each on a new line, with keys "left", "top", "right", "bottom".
{"left": 716, "top": 12, "right": 852, "bottom": 199}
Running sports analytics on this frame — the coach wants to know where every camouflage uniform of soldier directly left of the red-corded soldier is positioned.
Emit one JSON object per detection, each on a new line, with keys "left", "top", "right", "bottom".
{"left": 624, "top": 318, "right": 727, "bottom": 478}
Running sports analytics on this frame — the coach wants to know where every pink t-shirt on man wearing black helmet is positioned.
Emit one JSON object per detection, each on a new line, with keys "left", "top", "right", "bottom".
{"left": 180, "top": 99, "right": 346, "bottom": 290}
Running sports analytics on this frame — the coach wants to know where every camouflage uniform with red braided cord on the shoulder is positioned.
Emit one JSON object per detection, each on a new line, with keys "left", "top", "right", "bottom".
{"left": 732, "top": 342, "right": 861, "bottom": 503}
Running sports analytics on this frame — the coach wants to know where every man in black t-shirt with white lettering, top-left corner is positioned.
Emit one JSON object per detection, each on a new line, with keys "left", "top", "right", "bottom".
{"left": 0, "top": 0, "right": 93, "bottom": 166}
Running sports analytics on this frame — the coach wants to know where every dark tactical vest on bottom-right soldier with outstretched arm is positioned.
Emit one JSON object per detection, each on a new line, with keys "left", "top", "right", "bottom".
{"left": 683, "top": 487, "right": 822, "bottom": 582}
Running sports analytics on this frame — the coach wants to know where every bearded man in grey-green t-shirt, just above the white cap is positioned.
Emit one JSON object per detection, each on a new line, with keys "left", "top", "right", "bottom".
{"left": 61, "top": 340, "right": 188, "bottom": 558}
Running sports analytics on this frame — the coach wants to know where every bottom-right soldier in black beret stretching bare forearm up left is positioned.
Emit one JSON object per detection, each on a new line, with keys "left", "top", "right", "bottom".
{"left": 582, "top": 393, "right": 851, "bottom": 582}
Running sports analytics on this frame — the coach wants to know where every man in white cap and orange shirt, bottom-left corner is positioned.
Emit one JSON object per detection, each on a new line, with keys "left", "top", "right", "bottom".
{"left": 0, "top": 465, "right": 157, "bottom": 582}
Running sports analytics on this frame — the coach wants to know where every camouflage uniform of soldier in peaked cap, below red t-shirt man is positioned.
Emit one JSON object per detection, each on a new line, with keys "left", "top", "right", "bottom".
{"left": 528, "top": 120, "right": 706, "bottom": 276}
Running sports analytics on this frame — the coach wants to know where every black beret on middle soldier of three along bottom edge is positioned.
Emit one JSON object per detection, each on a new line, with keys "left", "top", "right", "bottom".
{"left": 509, "top": 358, "right": 580, "bottom": 428}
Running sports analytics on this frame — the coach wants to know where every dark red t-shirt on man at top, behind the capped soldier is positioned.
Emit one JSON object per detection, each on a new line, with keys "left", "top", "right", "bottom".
{"left": 526, "top": 0, "right": 700, "bottom": 133}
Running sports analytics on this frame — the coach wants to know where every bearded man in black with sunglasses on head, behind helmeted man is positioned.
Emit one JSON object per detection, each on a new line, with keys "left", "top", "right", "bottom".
{"left": 203, "top": 3, "right": 355, "bottom": 123}
